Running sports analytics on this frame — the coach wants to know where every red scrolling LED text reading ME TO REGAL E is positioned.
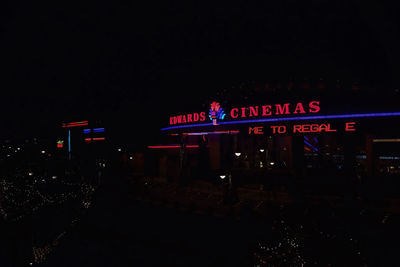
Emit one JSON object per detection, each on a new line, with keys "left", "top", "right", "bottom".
{"left": 249, "top": 122, "right": 356, "bottom": 134}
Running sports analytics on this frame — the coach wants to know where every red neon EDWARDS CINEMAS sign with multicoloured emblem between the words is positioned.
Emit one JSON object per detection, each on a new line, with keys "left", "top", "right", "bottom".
{"left": 169, "top": 101, "right": 321, "bottom": 125}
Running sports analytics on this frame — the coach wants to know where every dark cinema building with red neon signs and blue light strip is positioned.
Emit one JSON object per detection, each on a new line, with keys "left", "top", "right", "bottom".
{"left": 148, "top": 81, "right": 400, "bottom": 204}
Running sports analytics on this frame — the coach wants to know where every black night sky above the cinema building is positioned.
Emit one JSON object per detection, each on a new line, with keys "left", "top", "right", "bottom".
{"left": 0, "top": 0, "right": 400, "bottom": 142}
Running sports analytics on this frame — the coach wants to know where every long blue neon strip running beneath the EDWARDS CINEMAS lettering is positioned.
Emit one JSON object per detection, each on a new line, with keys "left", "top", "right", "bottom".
{"left": 161, "top": 112, "right": 400, "bottom": 131}
